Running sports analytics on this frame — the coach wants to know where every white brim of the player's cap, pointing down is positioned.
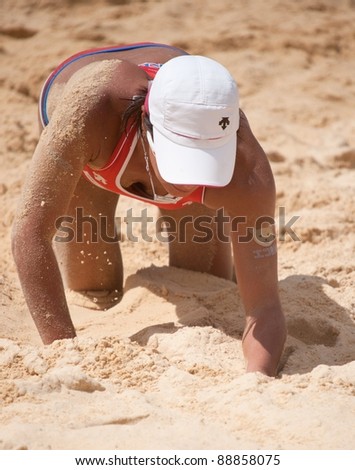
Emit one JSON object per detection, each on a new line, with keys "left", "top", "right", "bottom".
{"left": 154, "top": 127, "right": 237, "bottom": 186}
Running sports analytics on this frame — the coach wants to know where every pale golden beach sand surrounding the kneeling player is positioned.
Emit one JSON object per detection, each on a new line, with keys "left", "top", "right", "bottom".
{"left": 0, "top": 0, "right": 355, "bottom": 449}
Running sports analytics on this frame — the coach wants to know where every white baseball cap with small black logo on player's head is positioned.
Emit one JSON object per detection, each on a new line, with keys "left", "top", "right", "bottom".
{"left": 148, "top": 55, "right": 239, "bottom": 186}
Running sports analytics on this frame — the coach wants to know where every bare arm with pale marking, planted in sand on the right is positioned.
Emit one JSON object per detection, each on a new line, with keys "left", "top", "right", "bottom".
{"left": 207, "top": 109, "right": 286, "bottom": 376}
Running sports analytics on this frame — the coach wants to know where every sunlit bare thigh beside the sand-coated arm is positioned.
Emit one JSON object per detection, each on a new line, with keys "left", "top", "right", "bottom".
{"left": 54, "top": 177, "right": 123, "bottom": 298}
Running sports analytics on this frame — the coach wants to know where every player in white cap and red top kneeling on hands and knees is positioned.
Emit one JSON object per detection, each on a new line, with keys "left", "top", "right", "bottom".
{"left": 12, "top": 43, "right": 286, "bottom": 375}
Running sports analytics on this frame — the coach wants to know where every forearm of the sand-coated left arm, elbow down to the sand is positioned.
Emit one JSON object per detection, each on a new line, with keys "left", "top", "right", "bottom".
{"left": 13, "top": 233, "right": 75, "bottom": 344}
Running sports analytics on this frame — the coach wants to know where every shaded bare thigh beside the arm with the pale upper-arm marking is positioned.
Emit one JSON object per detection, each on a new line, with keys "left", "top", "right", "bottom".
{"left": 161, "top": 204, "right": 233, "bottom": 280}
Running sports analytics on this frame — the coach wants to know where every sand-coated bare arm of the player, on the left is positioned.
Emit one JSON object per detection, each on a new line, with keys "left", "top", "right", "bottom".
{"left": 12, "top": 82, "right": 99, "bottom": 344}
